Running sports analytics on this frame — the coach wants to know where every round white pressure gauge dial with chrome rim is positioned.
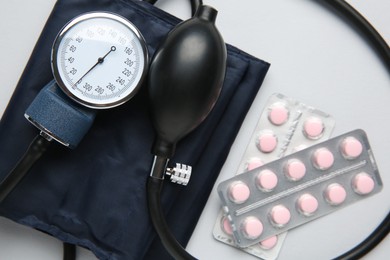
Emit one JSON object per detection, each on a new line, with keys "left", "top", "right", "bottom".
{"left": 52, "top": 12, "right": 148, "bottom": 108}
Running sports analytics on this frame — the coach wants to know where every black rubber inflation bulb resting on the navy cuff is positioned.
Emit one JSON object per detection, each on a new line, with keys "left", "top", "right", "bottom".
{"left": 148, "top": 5, "right": 227, "bottom": 158}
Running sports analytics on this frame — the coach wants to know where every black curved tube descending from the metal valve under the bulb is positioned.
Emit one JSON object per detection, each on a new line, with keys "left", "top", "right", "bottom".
{"left": 146, "top": 177, "right": 196, "bottom": 260}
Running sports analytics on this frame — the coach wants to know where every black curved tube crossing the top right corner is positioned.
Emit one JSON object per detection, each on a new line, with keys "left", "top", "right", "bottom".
{"left": 324, "top": 0, "right": 390, "bottom": 72}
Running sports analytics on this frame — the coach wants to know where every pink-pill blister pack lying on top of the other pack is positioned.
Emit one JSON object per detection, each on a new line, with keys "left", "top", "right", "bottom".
{"left": 217, "top": 130, "right": 383, "bottom": 247}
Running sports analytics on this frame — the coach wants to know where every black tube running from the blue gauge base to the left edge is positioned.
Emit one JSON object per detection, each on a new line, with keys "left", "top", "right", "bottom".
{"left": 0, "top": 135, "right": 50, "bottom": 203}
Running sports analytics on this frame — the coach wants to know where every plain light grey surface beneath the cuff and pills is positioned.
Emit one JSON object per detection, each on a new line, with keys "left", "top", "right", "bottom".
{"left": 0, "top": 0, "right": 390, "bottom": 260}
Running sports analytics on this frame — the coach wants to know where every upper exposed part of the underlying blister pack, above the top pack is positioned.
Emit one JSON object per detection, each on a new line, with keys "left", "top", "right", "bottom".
{"left": 237, "top": 94, "right": 335, "bottom": 173}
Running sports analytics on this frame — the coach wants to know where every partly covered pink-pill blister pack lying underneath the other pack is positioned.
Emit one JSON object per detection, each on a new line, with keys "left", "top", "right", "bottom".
{"left": 213, "top": 94, "right": 335, "bottom": 259}
